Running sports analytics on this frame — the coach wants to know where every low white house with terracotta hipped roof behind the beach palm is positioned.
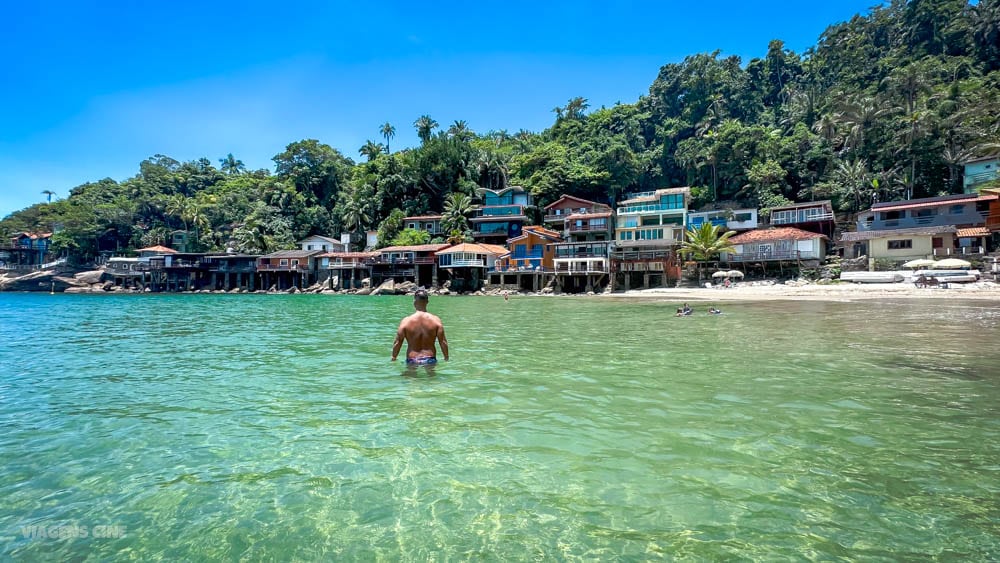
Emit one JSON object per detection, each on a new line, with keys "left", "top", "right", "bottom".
{"left": 719, "top": 227, "right": 829, "bottom": 265}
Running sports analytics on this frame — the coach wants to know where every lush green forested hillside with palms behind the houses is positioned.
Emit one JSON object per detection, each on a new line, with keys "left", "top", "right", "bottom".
{"left": 0, "top": 0, "right": 1000, "bottom": 259}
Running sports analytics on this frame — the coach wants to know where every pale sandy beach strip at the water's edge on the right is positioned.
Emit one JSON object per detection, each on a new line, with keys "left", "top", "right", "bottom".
{"left": 604, "top": 282, "right": 1000, "bottom": 301}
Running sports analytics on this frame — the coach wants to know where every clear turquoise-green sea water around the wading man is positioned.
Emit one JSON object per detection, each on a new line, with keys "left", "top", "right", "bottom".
{"left": 0, "top": 294, "right": 1000, "bottom": 561}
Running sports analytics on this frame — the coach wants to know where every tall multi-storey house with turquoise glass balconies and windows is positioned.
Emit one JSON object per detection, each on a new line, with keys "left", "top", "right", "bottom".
{"left": 611, "top": 187, "right": 691, "bottom": 289}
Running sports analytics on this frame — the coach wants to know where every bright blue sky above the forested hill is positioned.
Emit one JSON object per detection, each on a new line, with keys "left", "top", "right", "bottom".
{"left": 0, "top": 0, "right": 877, "bottom": 216}
